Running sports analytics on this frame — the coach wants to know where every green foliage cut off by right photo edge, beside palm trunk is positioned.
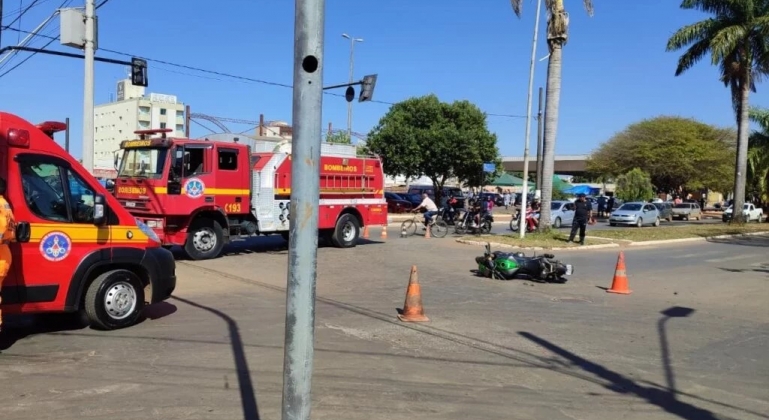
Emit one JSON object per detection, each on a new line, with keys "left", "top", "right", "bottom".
{"left": 747, "top": 107, "right": 769, "bottom": 204}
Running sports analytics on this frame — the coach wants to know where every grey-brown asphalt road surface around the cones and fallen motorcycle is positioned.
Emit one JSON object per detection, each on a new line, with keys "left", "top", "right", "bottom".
{"left": 0, "top": 232, "right": 769, "bottom": 420}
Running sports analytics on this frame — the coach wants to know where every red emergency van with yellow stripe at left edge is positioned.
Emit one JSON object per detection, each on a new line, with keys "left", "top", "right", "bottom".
{"left": 0, "top": 112, "right": 176, "bottom": 329}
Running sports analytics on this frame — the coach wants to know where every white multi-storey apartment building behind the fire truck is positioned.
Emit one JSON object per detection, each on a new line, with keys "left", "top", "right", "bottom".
{"left": 93, "top": 79, "right": 185, "bottom": 178}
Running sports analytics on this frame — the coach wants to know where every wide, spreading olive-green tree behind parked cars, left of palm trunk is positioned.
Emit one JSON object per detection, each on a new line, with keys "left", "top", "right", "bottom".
{"left": 587, "top": 116, "right": 734, "bottom": 193}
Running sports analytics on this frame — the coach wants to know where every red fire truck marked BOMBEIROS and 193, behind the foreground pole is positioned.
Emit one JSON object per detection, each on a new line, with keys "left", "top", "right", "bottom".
{"left": 115, "top": 129, "right": 387, "bottom": 260}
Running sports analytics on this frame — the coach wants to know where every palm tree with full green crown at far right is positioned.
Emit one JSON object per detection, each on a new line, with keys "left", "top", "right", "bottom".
{"left": 667, "top": 0, "right": 769, "bottom": 223}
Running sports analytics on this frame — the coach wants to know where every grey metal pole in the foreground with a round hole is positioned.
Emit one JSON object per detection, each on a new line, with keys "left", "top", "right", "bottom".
{"left": 281, "top": 0, "right": 326, "bottom": 420}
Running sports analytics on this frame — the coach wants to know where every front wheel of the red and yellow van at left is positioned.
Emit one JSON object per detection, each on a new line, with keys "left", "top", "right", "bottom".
{"left": 85, "top": 270, "right": 144, "bottom": 330}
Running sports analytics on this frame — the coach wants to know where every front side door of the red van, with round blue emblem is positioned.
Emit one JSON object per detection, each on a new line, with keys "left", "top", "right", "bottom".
{"left": 9, "top": 153, "right": 111, "bottom": 311}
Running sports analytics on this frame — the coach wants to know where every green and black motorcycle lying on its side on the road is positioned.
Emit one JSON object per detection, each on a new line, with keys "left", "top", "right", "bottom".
{"left": 475, "top": 243, "right": 574, "bottom": 283}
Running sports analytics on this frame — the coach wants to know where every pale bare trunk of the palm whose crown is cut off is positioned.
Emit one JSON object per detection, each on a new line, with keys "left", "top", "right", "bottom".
{"left": 539, "top": 40, "right": 563, "bottom": 230}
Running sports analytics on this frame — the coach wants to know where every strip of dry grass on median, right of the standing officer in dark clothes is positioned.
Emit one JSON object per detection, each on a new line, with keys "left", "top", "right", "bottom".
{"left": 587, "top": 223, "right": 769, "bottom": 242}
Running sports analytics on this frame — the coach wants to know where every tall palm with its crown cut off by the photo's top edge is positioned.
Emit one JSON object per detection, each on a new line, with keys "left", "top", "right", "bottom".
{"left": 510, "top": 0, "right": 593, "bottom": 229}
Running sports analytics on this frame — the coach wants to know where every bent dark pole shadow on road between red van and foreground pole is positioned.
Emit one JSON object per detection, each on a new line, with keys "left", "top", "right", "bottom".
{"left": 171, "top": 296, "right": 259, "bottom": 420}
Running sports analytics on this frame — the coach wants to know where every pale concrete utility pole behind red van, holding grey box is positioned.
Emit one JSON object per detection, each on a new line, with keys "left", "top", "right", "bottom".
{"left": 82, "top": 0, "right": 96, "bottom": 173}
